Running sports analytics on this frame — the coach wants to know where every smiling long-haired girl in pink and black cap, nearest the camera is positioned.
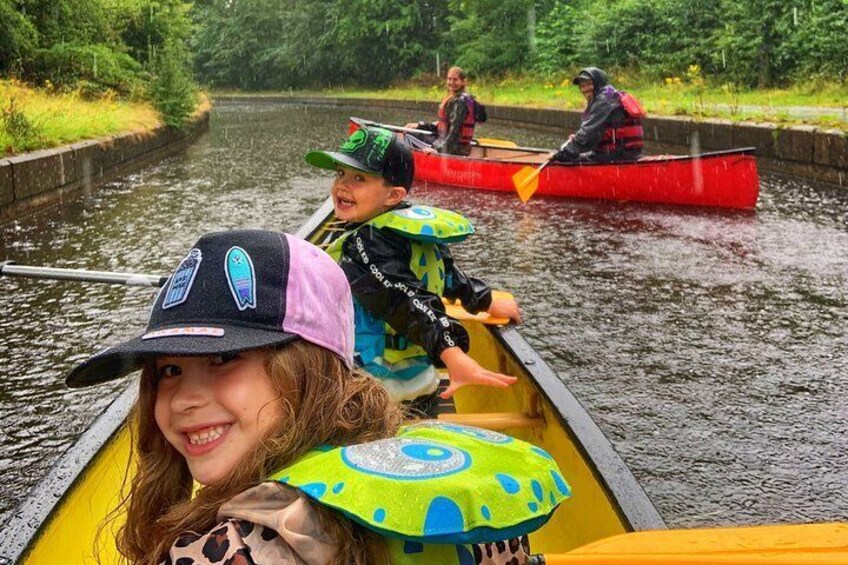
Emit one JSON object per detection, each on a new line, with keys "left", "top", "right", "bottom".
{"left": 67, "top": 231, "right": 569, "bottom": 565}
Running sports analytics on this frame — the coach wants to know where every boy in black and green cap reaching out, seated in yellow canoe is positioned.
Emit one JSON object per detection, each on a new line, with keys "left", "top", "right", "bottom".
{"left": 306, "top": 128, "right": 521, "bottom": 410}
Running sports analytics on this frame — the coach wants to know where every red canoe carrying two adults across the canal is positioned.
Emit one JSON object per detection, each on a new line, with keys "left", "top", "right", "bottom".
{"left": 351, "top": 118, "right": 760, "bottom": 209}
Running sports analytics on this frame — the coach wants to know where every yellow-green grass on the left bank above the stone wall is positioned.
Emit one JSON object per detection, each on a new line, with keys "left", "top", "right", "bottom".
{"left": 0, "top": 79, "right": 162, "bottom": 156}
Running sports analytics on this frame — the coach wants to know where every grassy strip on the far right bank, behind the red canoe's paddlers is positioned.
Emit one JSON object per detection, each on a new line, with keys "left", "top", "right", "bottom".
{"left": 304, "top": 72, "right": 848, "bottom": 131}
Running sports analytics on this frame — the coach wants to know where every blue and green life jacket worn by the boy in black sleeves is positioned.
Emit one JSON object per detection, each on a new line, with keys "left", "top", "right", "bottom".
{"left": 327, "top": 206, "right": 474, "bottom": 380}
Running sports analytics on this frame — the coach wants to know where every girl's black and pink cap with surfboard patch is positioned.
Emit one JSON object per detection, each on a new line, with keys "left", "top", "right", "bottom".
{"left": 66, "top": 230, "right": 353, "bottom": 387}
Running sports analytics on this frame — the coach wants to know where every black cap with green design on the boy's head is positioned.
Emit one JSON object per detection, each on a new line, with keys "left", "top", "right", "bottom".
{"left": 306, "top": 127, "right": 415, "bottom": 190}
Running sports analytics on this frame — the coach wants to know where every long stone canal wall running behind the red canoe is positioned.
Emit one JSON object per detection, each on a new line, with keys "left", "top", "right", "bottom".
{"left": 215, "top": 96, "right": 848, "bottom": 187}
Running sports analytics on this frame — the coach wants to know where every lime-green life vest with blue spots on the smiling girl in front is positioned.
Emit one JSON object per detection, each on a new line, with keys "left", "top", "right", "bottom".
{"left": 269, "top": 422, "right": 571, "bottom": 564}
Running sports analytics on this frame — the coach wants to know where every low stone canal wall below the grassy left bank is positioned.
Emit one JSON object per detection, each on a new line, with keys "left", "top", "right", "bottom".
{"left": 0, "top": 110, "right": 209, "bottom": 224}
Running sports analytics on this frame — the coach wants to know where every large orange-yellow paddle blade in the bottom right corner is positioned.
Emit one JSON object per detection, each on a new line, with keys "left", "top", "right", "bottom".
{"left": 545, "top": 523, "right": 848, "bottom": 565}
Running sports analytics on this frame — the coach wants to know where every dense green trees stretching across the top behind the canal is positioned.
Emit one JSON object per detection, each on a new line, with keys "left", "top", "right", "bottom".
{"left": 0, "top": 0, "right": 848, "bottom": 100}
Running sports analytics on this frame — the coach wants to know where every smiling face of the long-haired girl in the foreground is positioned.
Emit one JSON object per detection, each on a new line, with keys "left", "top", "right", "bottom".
{"left": 154, "top": 351, "right": 283, "bottom": 485}
